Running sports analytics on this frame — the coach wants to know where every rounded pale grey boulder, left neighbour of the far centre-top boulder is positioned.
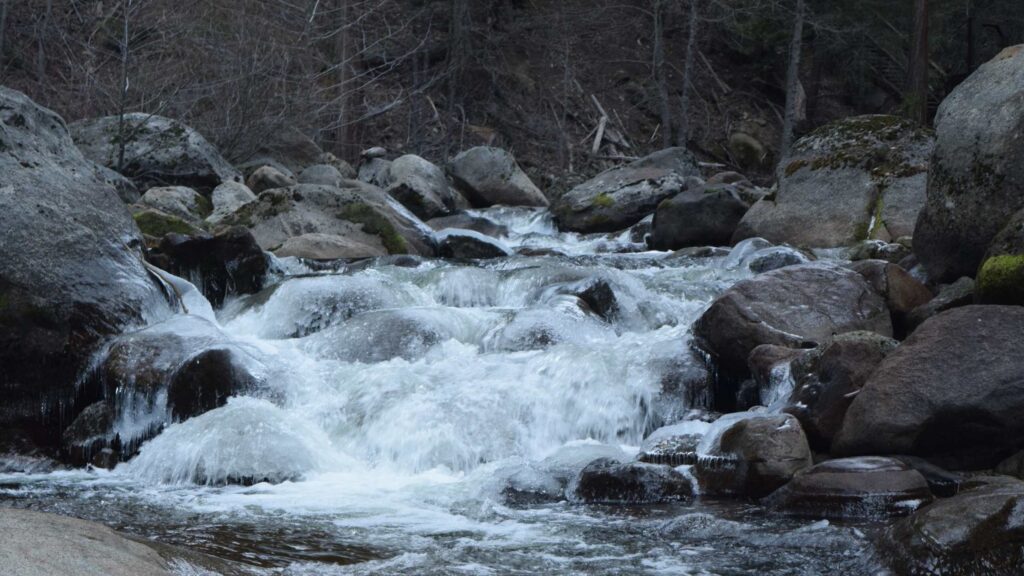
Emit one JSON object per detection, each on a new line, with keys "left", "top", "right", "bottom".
{"left": 387, "top": 154, "right": 469, "bottom": 220}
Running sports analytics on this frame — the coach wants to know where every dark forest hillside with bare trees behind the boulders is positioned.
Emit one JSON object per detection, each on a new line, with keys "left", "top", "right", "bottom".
{"left": 0, "top": 0, "right": 1024, "bottom": 190}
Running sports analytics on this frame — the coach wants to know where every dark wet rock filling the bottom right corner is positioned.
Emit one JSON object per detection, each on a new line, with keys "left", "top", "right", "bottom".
{"left": 878, "top": 477, "right": 1024, "bottom": 576}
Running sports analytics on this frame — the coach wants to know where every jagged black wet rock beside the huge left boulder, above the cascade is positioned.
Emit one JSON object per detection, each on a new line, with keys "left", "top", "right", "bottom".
{"left": 148, "top": 227, "right": 268, "bottom": 306}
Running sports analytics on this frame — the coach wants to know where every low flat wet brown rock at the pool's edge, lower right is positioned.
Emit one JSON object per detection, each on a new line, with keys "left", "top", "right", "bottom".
{"left": 765, "top": 456, "right": 932, "bottom": 519}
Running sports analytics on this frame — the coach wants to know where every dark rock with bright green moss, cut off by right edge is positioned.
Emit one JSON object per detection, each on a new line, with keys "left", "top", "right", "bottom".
{"left": 975, "top": 206, "right": 1024, "bottom": 305}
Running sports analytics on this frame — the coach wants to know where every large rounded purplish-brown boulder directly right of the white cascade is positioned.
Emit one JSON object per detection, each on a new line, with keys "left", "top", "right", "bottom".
{"left": 693, "top": 264, "right": 893, "bottom": 410}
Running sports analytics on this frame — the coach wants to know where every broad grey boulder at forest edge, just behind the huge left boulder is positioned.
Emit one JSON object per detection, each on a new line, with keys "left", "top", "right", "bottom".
{"left": 71, "top": 113, "right": 242, "bottom": 193}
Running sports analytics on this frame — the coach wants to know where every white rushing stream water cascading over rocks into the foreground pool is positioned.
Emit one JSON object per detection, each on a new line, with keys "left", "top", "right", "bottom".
{"left": 0, "top": 209, "right": 876, "bottom": 575}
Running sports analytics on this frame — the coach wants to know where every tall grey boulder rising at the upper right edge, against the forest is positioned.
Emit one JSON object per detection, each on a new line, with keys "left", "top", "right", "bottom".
{"left": 913, "top": 45, "right": 1024, "bottom": 282}
